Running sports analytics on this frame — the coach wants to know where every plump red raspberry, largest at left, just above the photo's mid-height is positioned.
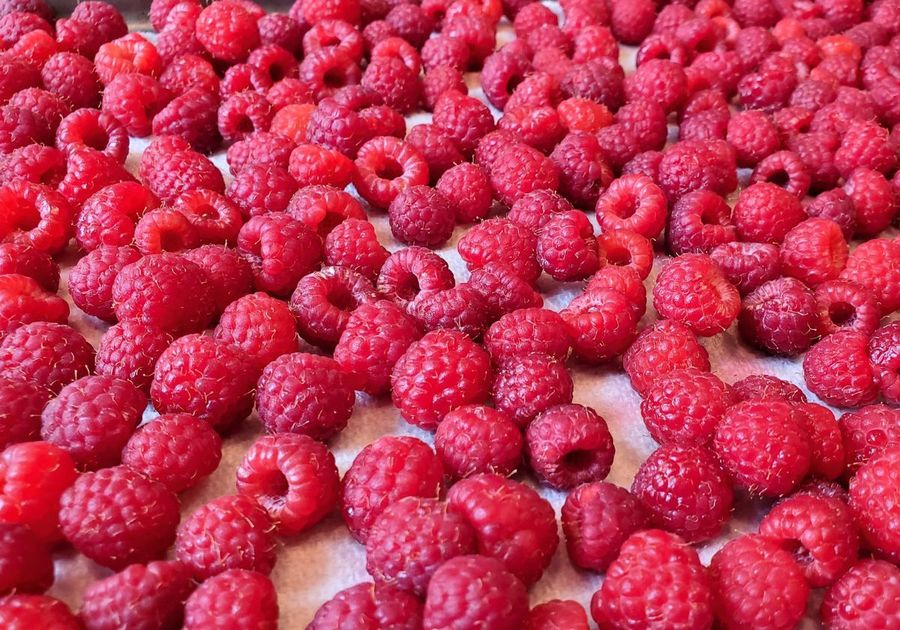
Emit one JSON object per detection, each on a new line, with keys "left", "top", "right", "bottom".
{"left": 112, "top": 253, "right": 213, "bottom": 335}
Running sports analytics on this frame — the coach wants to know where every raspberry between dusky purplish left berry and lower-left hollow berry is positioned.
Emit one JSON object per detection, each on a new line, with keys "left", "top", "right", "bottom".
{"left": 122, "top": 413, "right": 222, "bottom": 492}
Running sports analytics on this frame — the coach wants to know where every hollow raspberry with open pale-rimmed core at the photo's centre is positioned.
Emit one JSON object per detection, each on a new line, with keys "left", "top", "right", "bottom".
{"left": 377, "top": 247, "right": 455, "bottom": 309}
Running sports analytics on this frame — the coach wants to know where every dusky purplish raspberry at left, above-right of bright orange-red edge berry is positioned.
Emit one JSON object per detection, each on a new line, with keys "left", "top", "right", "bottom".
{"left": 41, "top": 376, "right": 147, "bottom": 470}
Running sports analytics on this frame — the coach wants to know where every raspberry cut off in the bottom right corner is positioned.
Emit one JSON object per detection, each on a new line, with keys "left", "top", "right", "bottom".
{"left": 819, "top": 564, "right": 900, "bottom": 630}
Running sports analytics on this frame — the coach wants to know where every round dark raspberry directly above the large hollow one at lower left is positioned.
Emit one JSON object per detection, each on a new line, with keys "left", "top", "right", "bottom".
{"left": 256, "top": 352, "right": 355, "bottom": 440}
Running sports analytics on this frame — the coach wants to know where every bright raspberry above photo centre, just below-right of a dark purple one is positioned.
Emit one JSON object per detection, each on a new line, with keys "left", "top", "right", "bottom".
{"left": 457, "top": 218, "right": 541, "bottom": 283}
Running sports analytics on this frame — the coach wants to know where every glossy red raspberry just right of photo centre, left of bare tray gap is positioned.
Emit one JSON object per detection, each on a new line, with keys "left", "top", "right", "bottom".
{"left": 560, "top": 288, "right": 638, "bottom": 364}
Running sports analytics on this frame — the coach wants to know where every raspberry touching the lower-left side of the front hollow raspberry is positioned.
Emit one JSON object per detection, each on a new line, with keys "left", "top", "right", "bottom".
{"left": 175, "top": 495, "right": 276, "bottom": 580}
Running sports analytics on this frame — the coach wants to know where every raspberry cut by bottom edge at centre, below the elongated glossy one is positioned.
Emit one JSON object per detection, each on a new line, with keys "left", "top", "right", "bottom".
{"left": 422, "top": 555, "right": 528, "bottom": 630}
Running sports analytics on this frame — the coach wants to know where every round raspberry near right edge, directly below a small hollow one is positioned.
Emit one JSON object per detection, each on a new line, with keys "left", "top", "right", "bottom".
{"left": 803, "top": 331, "right": 878, "bottom": 407}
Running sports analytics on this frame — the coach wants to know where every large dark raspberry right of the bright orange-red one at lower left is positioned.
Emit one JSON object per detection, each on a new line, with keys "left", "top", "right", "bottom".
{"left": 59, "top": 466, "right": 179, "bottom": 569}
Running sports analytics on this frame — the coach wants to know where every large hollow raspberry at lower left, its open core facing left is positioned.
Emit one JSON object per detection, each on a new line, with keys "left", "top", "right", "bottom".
{"left": 236, "top": 433, "right": 340, "bottom": 535}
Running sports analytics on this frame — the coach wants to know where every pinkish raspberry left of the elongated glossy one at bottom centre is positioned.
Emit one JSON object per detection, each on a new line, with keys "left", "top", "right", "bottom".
{"left": 366, "top": 497, "right": 475, "bottom": 597}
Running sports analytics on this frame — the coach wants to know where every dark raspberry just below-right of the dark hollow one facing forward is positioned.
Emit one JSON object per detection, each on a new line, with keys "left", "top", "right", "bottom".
{"left": 561, "top": 481, "right": 650, "bottom": 572}
